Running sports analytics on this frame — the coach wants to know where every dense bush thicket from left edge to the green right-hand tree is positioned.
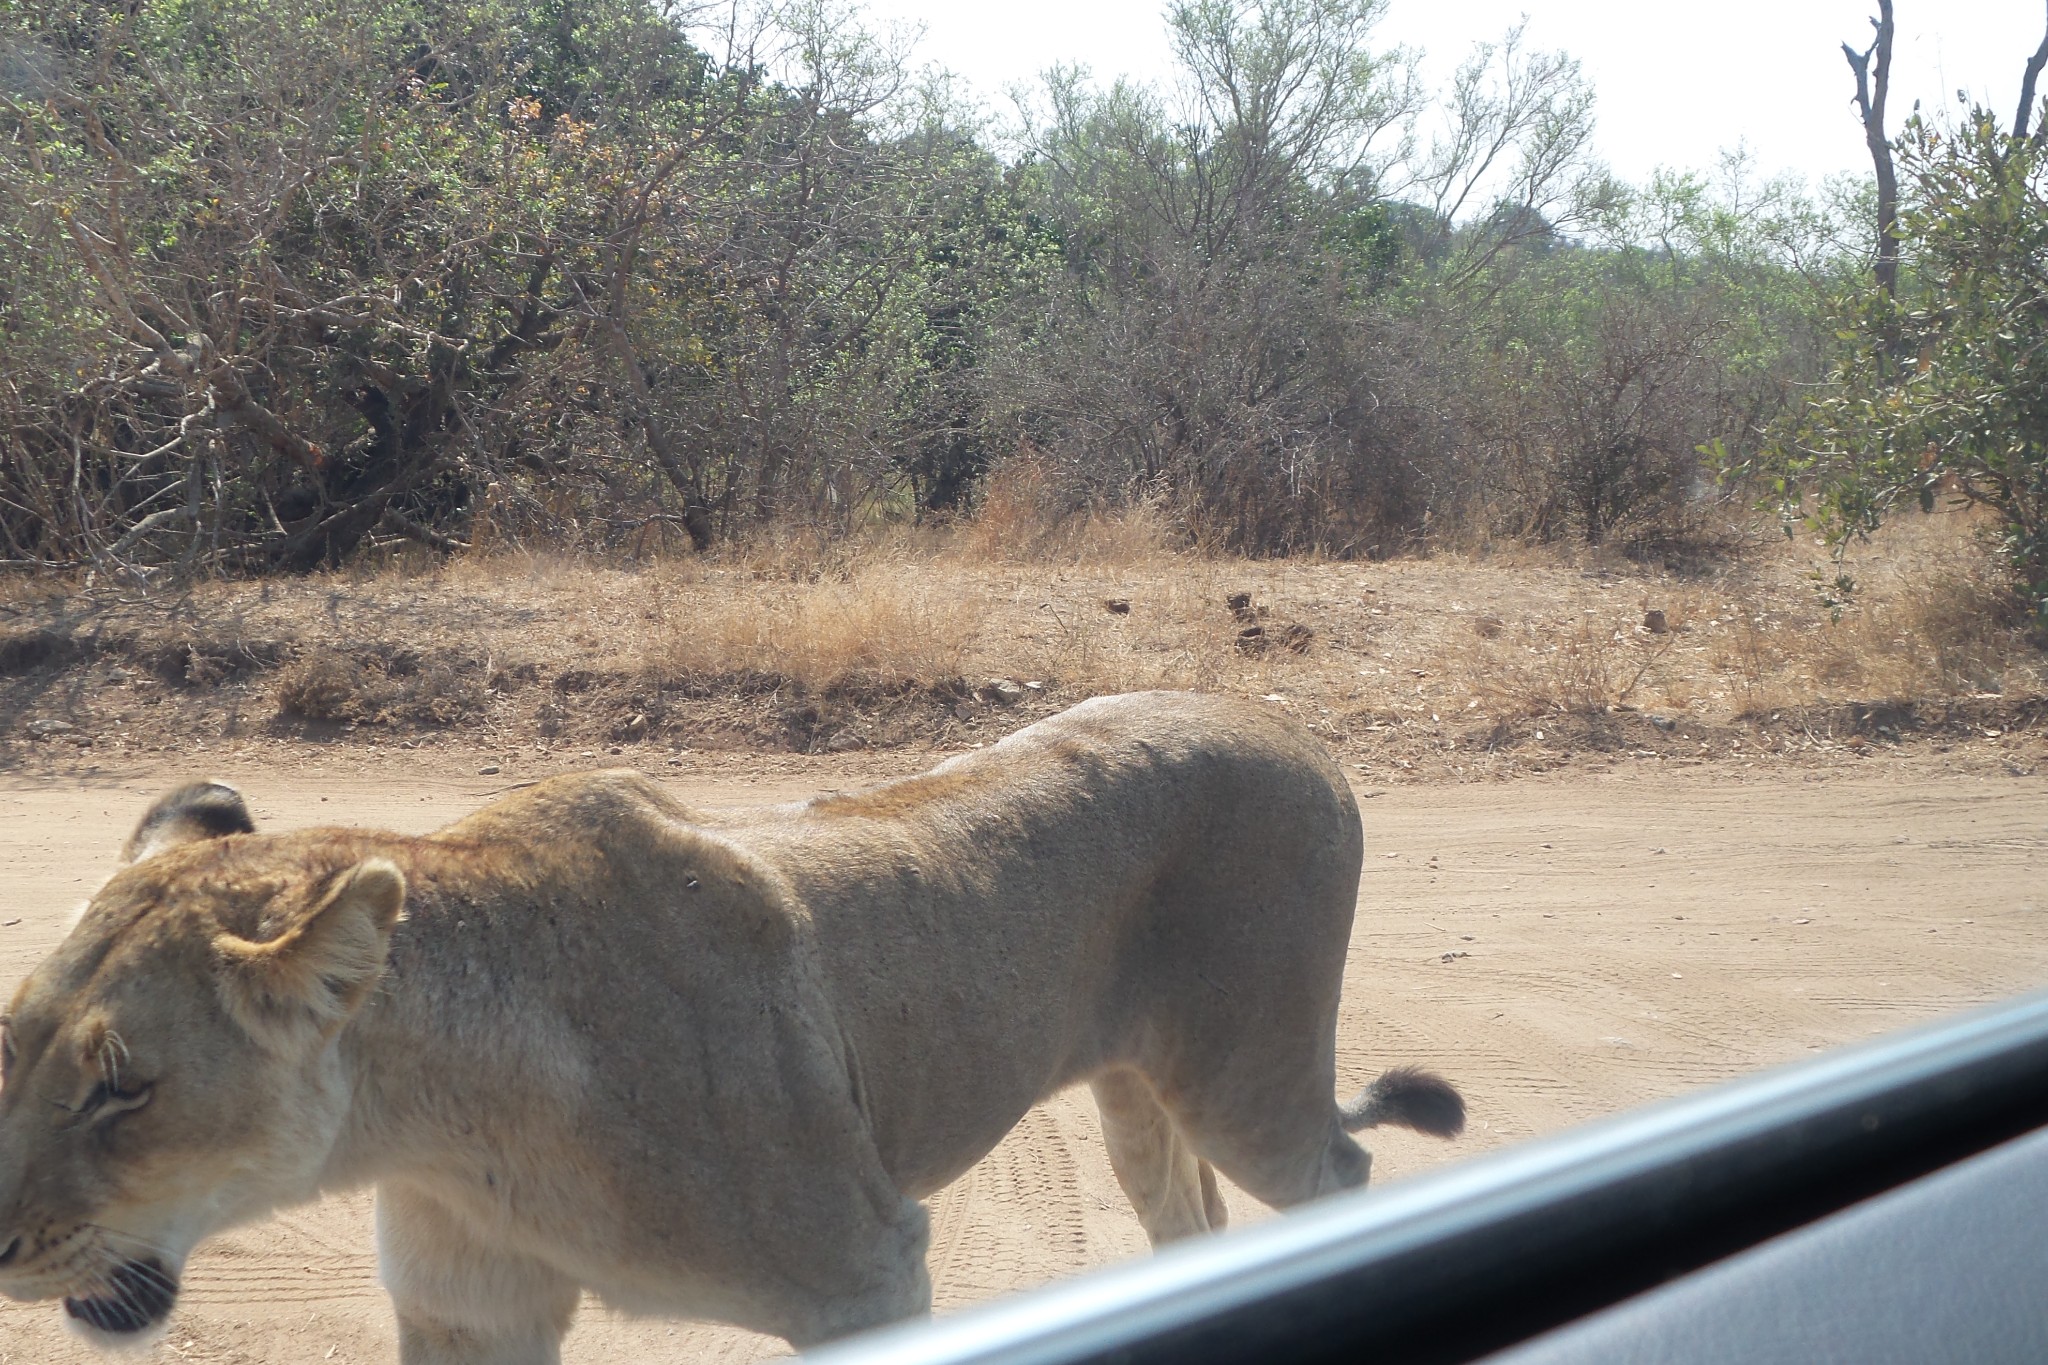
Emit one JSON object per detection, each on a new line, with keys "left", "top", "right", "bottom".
{"left": 0, "top": 0, "right": 1839, "bottom": 579}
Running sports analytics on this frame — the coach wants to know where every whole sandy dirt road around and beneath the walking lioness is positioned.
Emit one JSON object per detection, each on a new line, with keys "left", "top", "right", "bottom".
{"left": 0, "top": 755, "right": 2048, "bottom": 1365}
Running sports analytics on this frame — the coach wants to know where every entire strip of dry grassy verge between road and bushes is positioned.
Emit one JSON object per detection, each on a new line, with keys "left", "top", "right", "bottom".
{"left": 0, "top": 493, "right": 2048, "bottom": 774}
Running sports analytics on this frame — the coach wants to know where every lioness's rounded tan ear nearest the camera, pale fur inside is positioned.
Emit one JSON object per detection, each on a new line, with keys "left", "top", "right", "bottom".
{"left": 213, "top": 857, "right": 406, "bottom": 1046}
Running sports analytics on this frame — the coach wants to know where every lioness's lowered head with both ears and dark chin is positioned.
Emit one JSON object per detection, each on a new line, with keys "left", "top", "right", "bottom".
{"left": 0, "top": 782, "right": 406, "bottom": 1338}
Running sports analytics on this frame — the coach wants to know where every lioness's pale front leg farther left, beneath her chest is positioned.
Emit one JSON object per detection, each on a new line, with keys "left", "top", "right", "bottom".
{"left": 377, "top": 1185, "right": 578, "bottom": 1365}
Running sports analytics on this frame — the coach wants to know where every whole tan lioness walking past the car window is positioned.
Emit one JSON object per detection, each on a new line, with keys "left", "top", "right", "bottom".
{"left": 0, "top": 694, "right": 1462, "bottom": 1365}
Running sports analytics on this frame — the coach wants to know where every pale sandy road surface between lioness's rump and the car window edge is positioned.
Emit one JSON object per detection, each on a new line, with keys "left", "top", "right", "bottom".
{"left": 1339, "top": 778, "right": 2048, "bottom": 1144}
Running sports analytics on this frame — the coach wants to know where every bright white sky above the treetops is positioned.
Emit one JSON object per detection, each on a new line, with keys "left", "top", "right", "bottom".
{"left": 866, "top": 0, "right": 2048, "bottom": 182}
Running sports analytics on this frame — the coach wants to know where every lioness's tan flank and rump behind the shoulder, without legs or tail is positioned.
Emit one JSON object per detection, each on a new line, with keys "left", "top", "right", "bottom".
{"left": 737, "top": 692, "right": 1362, "bottom": 1191}
